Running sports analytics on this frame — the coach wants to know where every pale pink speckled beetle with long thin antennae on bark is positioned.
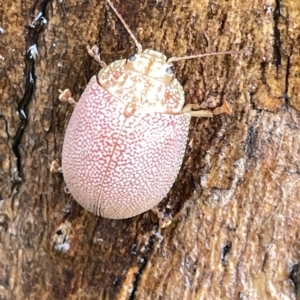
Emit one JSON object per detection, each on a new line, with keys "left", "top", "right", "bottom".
{"left": 56, "top": 0, "right": 243, "bottom": 219}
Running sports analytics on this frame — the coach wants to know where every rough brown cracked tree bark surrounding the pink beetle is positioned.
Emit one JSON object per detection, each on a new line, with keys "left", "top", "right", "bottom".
{"left": 0, "top": 0, "right": 300, "bottom": 299}
